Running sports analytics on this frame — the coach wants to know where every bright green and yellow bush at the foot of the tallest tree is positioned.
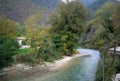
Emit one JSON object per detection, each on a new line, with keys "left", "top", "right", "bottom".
{"left": 52, "top": 32, "right": 77, "bottom": 55}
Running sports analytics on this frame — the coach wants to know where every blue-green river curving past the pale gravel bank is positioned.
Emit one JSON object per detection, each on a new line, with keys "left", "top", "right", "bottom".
{"left": 11, "top": 49, "right": 100, "bottom": 81}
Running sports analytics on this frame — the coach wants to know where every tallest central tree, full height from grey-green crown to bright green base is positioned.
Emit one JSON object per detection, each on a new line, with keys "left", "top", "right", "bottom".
{"left": 50, "top": 1, "right": 87, "bottom": 55}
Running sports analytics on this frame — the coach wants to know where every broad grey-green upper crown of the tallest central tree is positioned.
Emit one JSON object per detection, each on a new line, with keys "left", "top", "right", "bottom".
{"left": 50, "top": 1, "right": 87, "bottom": 36}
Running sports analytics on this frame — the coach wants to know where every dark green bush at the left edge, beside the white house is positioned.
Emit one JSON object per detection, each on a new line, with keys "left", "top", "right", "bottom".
{"left": 0, "top": 37, "right": 18, "bottom": 68}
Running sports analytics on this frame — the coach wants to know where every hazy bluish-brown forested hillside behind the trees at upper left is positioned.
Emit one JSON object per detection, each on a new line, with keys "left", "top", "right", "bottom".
{"left": 0, "top": 0, "right": 58, "bottom": 23}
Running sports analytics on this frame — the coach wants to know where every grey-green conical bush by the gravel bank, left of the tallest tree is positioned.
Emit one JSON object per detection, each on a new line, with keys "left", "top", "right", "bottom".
{"left": 38, "top": 37, "right": 60, "bottom": 62}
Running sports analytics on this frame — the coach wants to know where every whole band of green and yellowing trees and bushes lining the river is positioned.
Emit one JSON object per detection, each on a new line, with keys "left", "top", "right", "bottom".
{"left": 0, "top": 1, "right": 120, "bottom": 81}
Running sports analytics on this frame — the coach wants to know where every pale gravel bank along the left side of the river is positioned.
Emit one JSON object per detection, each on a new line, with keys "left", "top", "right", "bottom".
{"left": 0, "top": 54, "right": 89, "bottom": 81}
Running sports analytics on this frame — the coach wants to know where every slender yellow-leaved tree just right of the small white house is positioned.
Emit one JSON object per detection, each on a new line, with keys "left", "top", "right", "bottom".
{"left": 25, "top": 13, "right": 43, "bottom": 57}
